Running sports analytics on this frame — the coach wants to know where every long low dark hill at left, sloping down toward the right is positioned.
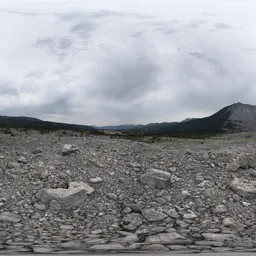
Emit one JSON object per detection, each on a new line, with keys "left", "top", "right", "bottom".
{"left": 0, "top": 116, "right": 97, "bottom": 132}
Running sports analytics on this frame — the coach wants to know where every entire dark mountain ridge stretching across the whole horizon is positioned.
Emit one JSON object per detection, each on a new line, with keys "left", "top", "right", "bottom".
{"left": 0, "top": 102, "right": 256, "bottom": 134}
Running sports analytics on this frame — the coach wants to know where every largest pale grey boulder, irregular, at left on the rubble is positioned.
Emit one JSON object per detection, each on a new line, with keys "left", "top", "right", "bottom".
{"left": 40, "top": 182, "right": 94, "bottom": 209}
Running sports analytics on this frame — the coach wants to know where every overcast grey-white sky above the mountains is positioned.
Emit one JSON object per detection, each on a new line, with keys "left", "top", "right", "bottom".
{"left": 0, "top": 0, "right": 256, "bottom": 125}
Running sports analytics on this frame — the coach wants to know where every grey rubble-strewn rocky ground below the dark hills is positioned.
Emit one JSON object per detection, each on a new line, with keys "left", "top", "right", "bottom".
{"left": 0, "top": 130, "right": 256, "bottom": 254}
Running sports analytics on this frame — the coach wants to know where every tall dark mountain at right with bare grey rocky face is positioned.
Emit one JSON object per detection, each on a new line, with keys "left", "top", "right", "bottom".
{"left": 139, "top": 102, "right": 256, "bottom": 133}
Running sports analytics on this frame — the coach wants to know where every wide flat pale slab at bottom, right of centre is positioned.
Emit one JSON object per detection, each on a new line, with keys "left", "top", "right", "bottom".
{"left": 145, "top": 232, "right": 191, "bottom": 245}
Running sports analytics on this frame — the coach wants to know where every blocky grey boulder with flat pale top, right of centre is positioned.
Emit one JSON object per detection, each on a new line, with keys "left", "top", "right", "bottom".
{"left": 140, "top": 169, "right": 171, "bottom": 189}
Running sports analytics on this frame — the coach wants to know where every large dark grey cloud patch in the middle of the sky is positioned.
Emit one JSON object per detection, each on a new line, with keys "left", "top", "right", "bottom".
{"left": 90, "top": 52, "right": 158, "bottom": 102}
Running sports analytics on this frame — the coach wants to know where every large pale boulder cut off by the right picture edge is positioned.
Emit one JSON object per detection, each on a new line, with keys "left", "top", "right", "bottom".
{"left": 230, "top": 178, "right": 256, "bottom": 198}
